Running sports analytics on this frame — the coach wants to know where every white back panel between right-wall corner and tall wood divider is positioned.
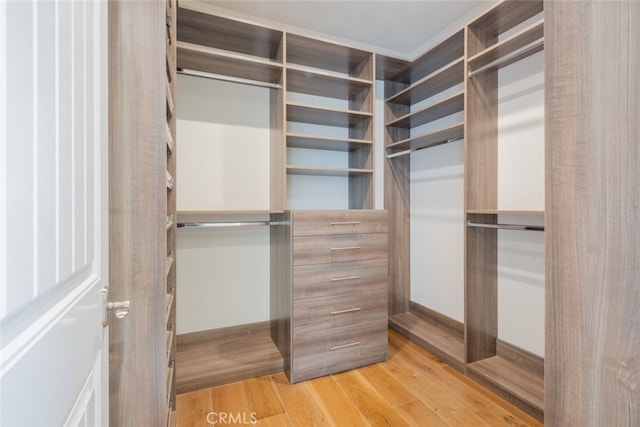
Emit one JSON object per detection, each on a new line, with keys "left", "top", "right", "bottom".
{"left": 411, "top": 141, "right": 464, "bottom": 322}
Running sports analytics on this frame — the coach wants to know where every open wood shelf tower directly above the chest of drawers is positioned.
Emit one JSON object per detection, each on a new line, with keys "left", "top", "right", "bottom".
{"left": 285, "top": 34, "right": 375, "bottom": 209}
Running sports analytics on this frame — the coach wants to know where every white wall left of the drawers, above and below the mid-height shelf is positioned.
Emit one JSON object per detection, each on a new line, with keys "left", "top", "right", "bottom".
{"left": 176, "top": 75, "right": 270, "bottom": 334}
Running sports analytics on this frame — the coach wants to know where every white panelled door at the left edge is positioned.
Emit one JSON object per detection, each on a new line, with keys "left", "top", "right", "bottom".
{"left": 0, "top": 0, "right": 109, "bottom": 427}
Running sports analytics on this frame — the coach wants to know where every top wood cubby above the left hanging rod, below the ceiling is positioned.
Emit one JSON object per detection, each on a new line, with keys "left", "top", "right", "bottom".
{"left": 177, "top": 2, "right": 283, "bottom": 61}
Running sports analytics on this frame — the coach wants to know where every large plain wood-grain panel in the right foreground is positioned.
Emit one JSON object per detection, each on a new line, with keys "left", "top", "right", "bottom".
{"left": 545, "top": 1, "right": 640, "bottom": 426}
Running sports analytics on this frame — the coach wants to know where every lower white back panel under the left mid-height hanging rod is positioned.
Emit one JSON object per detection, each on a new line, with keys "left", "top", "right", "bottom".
{"left": 176, "top": 227, "right": 270, "bottom": 334}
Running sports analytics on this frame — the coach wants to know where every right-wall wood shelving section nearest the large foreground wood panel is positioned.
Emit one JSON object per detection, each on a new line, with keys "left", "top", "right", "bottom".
{"left": 465, "top": 1, "right": 544, "bottom": 419}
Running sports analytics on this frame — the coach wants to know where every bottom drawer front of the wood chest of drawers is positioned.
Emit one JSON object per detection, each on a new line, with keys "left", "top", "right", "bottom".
{"left": 291, "top": 317, "right": 387, "bottom": 382}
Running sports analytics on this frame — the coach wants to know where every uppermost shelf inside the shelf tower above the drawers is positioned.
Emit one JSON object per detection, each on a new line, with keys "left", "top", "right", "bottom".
{"left": 287, "top": 65, "right": 372, "bottom": 100}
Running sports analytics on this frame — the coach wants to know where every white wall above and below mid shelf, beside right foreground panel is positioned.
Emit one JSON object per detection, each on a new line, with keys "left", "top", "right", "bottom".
{"left": 498, "top": 52, "right": 545, "bottom": 356}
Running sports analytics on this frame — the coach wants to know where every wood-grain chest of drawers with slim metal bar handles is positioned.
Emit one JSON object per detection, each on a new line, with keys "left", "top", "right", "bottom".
{"left": 290, "top": 210, "right": 388, "bottom": 382}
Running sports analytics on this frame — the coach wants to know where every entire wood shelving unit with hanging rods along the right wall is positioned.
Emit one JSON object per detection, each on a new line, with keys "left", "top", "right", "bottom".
{"left": 377, "top": 0, "right": 544, "bottom": 419}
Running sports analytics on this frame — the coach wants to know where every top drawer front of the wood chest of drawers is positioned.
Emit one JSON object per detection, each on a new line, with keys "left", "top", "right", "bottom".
{"left": 292, "top": 210, "right": 388, "bottom": 236}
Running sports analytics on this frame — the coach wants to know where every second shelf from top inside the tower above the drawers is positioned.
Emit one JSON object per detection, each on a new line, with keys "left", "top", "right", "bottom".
{"left": 287, "top": 102, "right": 373, "bottom": 127}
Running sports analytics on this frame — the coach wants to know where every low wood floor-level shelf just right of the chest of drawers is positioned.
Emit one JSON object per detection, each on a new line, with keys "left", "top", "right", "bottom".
{"left": 389, "top": 313, "right": 464, "bottom": 372}
